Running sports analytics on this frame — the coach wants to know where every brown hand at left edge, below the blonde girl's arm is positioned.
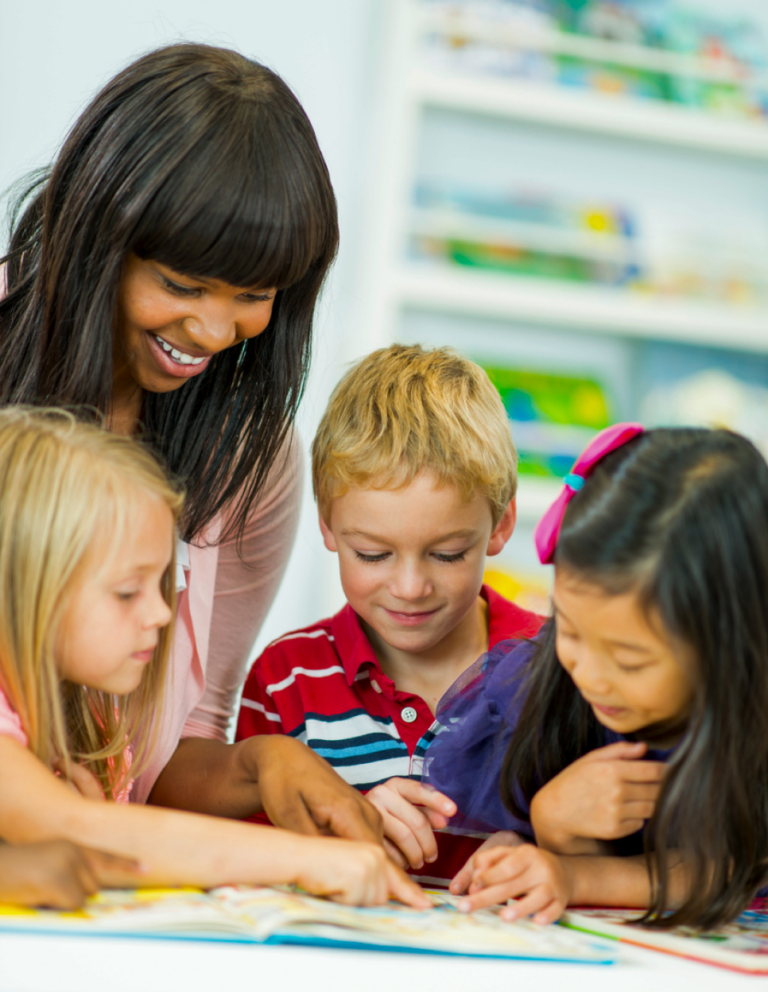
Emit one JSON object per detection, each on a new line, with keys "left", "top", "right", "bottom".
{"left": 0, "top": 840, "right": 143, "bottom": 909}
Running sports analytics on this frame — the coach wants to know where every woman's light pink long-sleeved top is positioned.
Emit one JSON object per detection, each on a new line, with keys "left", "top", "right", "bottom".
{"left": 130, "top": 437, "right": 301, "bottom": 803}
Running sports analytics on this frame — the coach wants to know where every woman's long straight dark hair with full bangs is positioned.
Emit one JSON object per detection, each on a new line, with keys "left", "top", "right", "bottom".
{"left": 0, "top": 45, "right": 338, "bottom": 539}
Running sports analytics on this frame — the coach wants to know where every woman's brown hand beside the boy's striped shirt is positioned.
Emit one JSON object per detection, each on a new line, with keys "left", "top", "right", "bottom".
{"left": 249, "top": 734, "right": 384, "bottom": 844}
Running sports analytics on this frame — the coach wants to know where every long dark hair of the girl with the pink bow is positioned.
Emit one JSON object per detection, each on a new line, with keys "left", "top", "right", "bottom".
{"left": 502, "top": 429, "right": 768, "bottom": 929}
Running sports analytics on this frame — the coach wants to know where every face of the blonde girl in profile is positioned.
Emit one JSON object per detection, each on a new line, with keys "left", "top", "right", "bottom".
{"left": 56, "top": 495, "right": 174, "bottom": 695}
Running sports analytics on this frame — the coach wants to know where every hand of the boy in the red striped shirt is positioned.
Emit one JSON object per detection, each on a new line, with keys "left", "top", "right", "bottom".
{"left": 367, "top": 778, "right": 456, "bottom": 868}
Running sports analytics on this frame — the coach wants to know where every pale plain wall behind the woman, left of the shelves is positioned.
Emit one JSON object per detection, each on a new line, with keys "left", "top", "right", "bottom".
{"left": 0, "top": 0, "right": 382, "bottom": 660}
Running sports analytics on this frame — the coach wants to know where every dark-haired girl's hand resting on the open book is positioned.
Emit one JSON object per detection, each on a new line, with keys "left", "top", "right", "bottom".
{"left": 459, "top": 844, "right": 577, "bottom": 923}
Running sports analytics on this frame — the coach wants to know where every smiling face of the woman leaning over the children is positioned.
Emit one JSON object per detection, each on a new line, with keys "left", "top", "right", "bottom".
{"left": 115, "top": 255, "right": 276, "bottom": 404}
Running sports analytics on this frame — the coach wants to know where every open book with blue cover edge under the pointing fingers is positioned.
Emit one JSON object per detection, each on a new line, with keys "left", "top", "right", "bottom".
{"left": 0, "top": 886, "right": 616, "bottom": 964}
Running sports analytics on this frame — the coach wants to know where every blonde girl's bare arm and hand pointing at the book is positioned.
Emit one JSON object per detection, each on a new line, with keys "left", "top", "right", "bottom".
{"left": 0, "top": 737, "right": 429, "bottom": 908}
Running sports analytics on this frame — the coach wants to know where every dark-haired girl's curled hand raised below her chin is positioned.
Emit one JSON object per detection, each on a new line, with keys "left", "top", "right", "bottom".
{"left": 531, "top": 741, "right": 667, "bottom": 854}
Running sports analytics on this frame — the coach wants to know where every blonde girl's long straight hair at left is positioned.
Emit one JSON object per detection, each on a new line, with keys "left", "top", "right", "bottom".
{"left": 0, "top": 407, "right": 182, "bottom": 798}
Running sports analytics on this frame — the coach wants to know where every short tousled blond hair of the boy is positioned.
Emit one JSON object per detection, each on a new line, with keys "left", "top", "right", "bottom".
{"left": 312, "top": 345, "right": 517, "bottom": 527}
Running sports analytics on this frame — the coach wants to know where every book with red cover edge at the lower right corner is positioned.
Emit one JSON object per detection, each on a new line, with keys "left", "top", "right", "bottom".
{"left": 562, "top": 899, "right": 768, "bottom": 975}
